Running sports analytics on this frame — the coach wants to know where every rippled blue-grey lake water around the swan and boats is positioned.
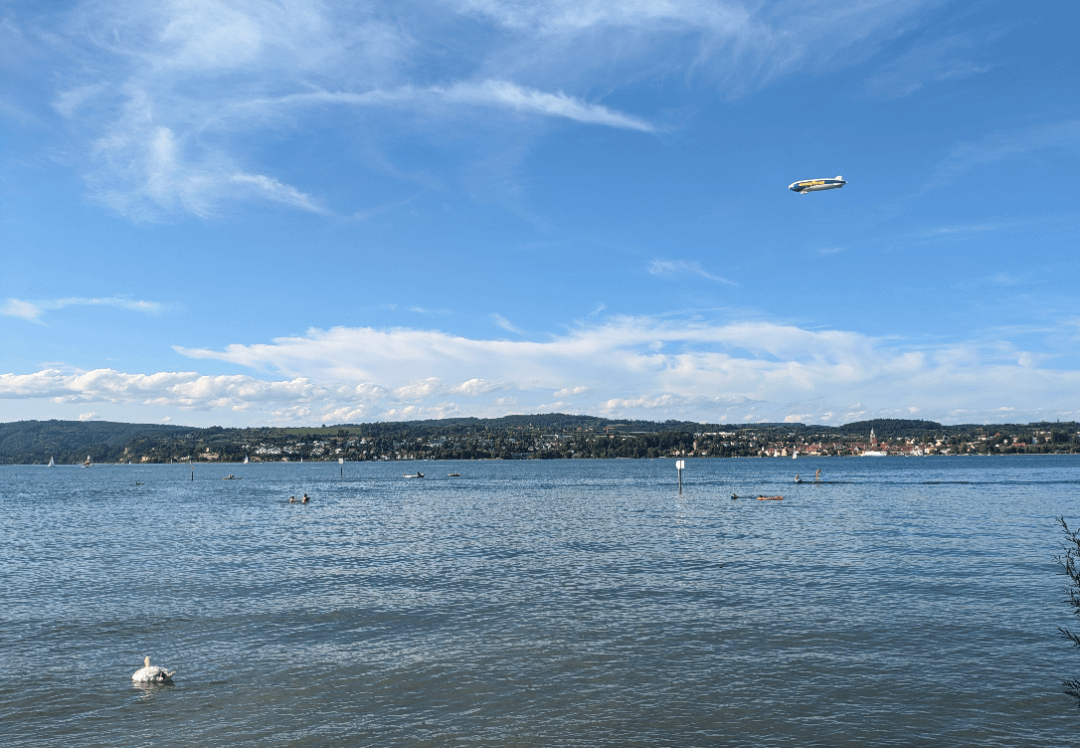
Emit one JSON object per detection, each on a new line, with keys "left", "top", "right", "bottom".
{"left": 0, "top": 457, "right": 1080, "bottom": 748}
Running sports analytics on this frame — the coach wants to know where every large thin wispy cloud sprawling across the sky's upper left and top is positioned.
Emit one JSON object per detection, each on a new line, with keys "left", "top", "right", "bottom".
{"left": 12, "top": 0, "right": 934, "bottom": 220}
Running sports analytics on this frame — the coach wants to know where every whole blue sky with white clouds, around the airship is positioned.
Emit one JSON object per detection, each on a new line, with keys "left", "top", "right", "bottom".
{"left": 0, "top": 0, "right": 1080, "bottom": 425}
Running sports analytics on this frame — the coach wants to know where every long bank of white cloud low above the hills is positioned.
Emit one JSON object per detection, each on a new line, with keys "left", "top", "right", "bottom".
{"left": 0, "top": 316, "right": 1080, "bottom": 423}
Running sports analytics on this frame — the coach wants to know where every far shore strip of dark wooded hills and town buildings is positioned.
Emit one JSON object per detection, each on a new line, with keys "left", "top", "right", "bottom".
{"left": 0, "top": 413, "right": 1080, "bottom": 464}
